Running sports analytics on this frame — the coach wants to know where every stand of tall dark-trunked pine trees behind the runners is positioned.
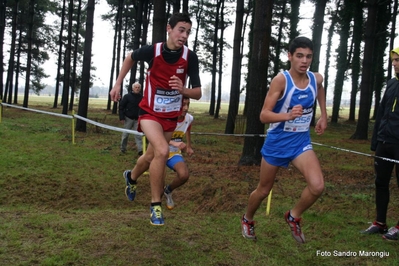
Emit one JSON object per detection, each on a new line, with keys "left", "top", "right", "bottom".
{"left": 0, "top": 0, "right": 398, "bottom": 165}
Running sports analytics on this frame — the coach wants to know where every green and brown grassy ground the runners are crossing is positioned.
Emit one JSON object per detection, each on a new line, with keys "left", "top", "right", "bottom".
{"left": 0, "top": 97, "right": 399, "bottom": 266}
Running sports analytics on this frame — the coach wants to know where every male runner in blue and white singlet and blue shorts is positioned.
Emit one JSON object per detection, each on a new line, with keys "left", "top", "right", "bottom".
{"left": 241, "top": 37, "right": 327, "bottom": 243}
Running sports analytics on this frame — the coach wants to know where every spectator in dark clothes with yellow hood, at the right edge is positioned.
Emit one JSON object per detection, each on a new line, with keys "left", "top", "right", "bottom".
{"left": 362, "top": 47, "right": 399, "bottom": 240}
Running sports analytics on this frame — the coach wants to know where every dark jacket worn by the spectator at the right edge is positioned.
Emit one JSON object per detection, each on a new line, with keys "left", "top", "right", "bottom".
{"left": 371, "top": 78, "right": 399, "bottom": 151}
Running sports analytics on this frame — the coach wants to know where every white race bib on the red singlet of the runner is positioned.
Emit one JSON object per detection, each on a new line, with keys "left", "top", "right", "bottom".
{"left": 154, "top": 88, "right": 182, "bottom": 113}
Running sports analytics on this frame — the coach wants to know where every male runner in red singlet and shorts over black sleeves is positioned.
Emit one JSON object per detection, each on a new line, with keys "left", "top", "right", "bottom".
{"left": 110, "top": 13, "right": 202, "bottom": 226}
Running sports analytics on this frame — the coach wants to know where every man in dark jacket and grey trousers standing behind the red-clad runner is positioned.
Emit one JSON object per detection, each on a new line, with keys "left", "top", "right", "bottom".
{"left": 119, "top": 82, "right": 143, "bottom": 156}
